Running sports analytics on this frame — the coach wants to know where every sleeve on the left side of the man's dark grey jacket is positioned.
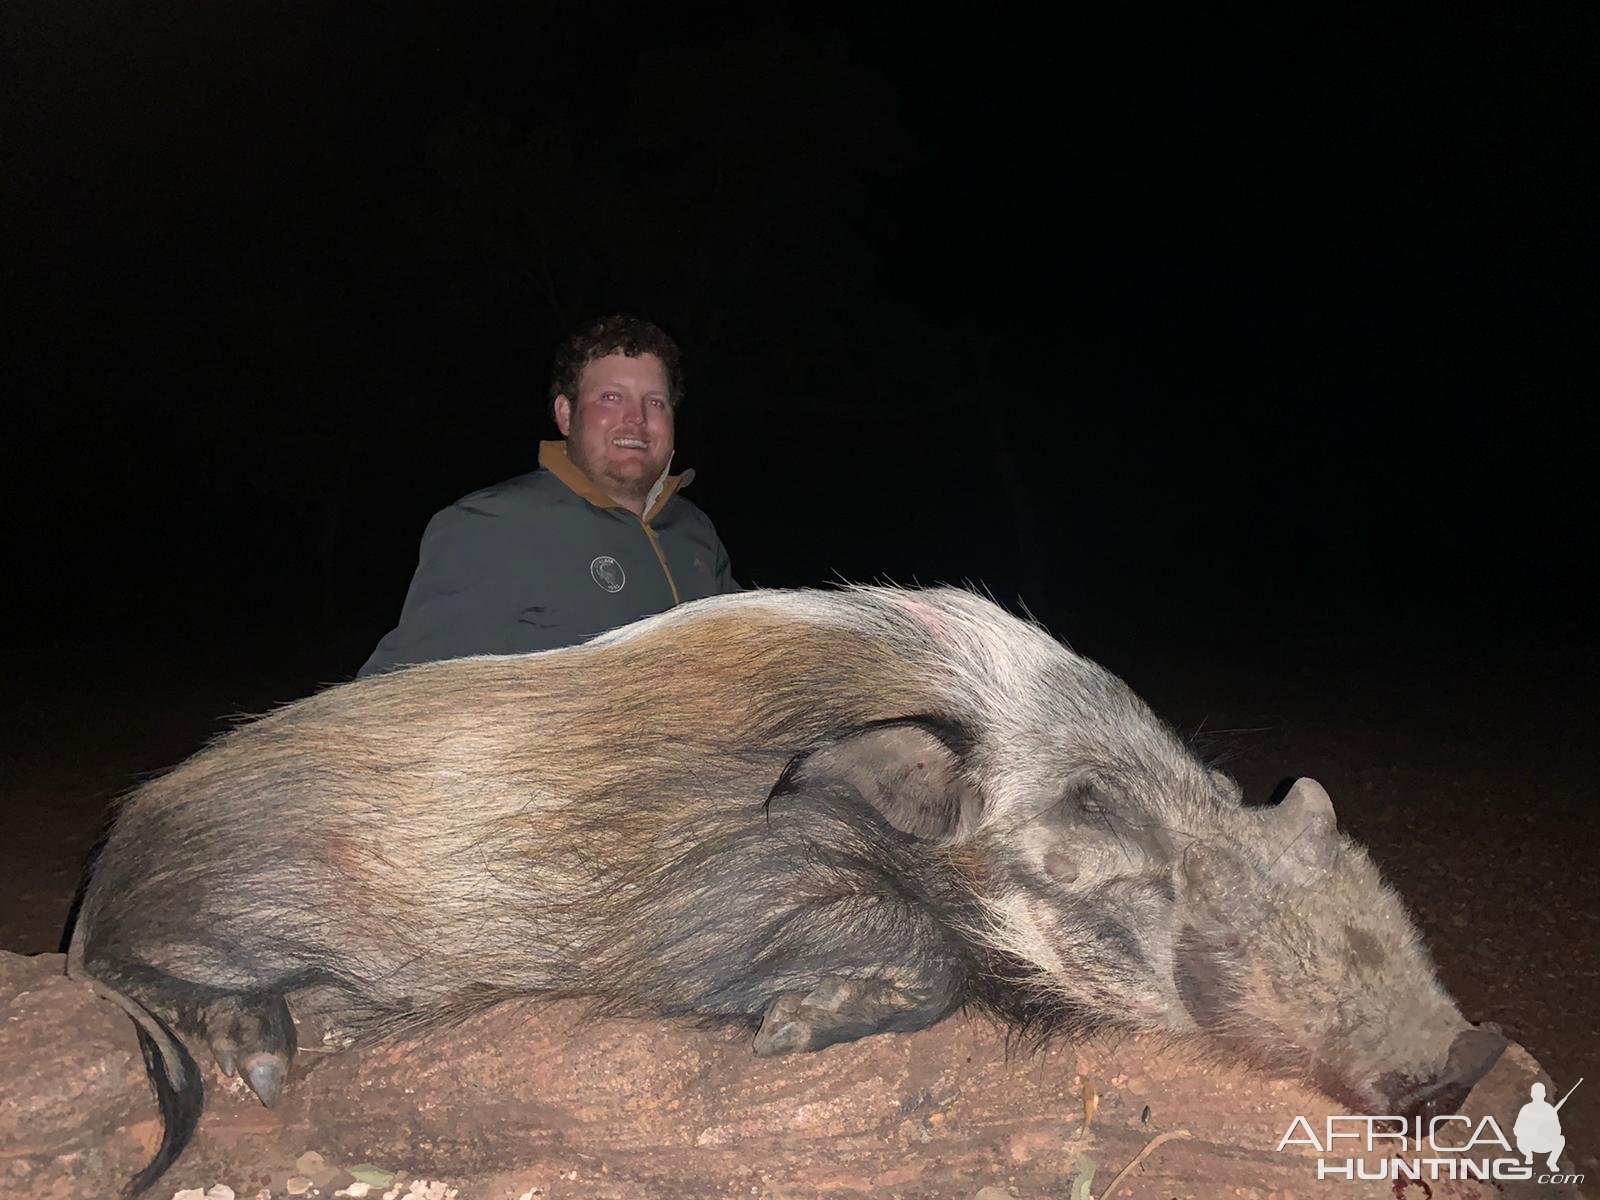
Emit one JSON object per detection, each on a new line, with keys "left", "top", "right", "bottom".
{"left": 357, "top": 504, "right": 504, "bottom": 677}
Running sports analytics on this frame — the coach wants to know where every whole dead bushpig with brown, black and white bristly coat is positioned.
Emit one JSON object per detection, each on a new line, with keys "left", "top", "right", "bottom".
{"left": 67, "top": 587, "right": 1504, "bottom": 1194}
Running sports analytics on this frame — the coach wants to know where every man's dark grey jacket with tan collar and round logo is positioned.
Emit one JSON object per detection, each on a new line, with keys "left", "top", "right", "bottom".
{"left": 358, "top": 442, "right": 739, "bottom": 675}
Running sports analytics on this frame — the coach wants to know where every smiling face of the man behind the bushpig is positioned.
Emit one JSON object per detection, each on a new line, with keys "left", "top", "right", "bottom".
{"left": 555, "top": 354, "right": 672, "bottom": 512}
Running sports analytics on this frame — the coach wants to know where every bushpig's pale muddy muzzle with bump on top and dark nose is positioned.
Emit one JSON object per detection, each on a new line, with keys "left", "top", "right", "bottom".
{"left": 1173, "top": 779, "right": 1506, "bottom": 1117}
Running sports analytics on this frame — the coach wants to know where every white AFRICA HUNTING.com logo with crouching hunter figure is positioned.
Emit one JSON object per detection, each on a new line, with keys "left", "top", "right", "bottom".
{"left": 1277, "top": 1080, "right": 1584, "bottom": 1184}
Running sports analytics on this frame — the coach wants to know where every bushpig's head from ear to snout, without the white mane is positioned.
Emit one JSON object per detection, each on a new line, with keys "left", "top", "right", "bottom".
{"left": 784, "top": 718, "right": 1506, "bottom": 1117}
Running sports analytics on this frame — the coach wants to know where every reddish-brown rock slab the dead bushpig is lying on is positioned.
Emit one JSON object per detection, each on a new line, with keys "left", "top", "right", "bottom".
{"left": 0, "top": 955, "right": 1576, "bottom": 1200}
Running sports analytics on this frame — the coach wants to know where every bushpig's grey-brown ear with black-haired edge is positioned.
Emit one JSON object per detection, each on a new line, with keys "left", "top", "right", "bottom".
{"left": 766, "top": 717, "right": 981, "bottom": 842}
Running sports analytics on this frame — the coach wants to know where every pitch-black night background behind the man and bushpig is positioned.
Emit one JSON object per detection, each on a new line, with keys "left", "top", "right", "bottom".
{"left": 0, "top": 3, "right": 1600, "bottom": 1177}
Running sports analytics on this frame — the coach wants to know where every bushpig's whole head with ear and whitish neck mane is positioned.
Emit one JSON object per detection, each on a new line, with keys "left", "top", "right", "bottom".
{"left": 816, "top": 590, "right": 1506, "bottom": 1115}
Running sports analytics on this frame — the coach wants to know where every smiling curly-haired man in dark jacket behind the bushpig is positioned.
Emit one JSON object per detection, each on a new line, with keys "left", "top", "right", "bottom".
{"left": 358, "top": 317, "right": 739, "bottom": 675}
